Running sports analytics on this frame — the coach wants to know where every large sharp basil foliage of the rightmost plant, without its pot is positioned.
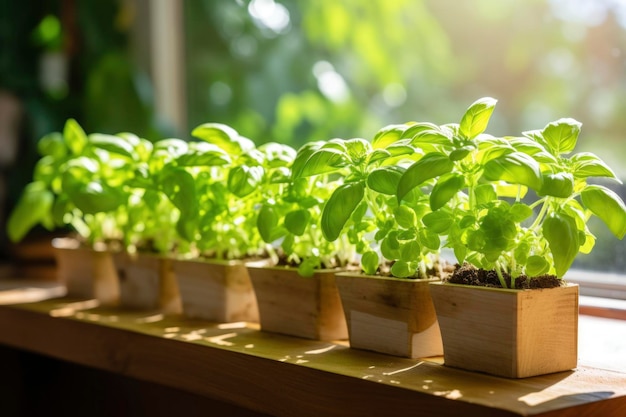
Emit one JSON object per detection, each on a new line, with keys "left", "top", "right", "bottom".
{"left": 397, "top": 98, "right": 626, "bottom": 288}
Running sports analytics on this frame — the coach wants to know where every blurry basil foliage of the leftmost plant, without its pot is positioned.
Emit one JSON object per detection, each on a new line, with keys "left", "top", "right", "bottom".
{"left": 7, "top": 119, "right": 129, "bottom": 246}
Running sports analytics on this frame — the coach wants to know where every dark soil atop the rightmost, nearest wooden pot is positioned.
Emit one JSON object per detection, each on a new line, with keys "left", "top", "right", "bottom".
{"left": 447, "top": 263, "right": 565, "bottom": 289}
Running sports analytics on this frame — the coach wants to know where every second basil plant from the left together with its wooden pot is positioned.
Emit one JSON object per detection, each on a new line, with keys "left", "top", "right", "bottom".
{"left": 103, "top": 134, "right": 204, "bottom": 313}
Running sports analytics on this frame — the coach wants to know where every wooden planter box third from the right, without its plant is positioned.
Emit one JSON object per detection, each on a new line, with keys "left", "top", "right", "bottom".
{"left": 248, "top": 264, "right": 348, "bottom": 340}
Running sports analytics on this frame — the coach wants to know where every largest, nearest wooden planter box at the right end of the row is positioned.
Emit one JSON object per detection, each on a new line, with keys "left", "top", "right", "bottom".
{"left": 430, "top": 283, "right": 578, "bottom": 378}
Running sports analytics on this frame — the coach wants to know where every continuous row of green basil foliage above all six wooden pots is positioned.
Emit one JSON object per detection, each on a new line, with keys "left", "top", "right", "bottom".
{"left": 8, "top": 98, "right": 626, "bottom": 287}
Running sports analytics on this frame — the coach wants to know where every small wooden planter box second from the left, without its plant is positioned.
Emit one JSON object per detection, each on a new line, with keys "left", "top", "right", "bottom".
{"left": 114, "top": 253, "right": 182, "bottom": 314}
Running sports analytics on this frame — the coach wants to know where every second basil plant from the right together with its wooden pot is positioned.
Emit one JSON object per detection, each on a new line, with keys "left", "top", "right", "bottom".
{"left": 295, "top": 132, "right": 444, "bottom": 358}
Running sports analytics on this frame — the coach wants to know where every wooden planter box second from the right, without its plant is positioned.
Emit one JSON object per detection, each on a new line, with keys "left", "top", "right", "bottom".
{"left": 337, "top": 273, "right": 443, "bottom": 358}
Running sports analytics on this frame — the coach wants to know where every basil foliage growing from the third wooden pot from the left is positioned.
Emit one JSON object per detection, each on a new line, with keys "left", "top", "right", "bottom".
{"left": 147, "top": 123, "right": 284, "bottom": 260}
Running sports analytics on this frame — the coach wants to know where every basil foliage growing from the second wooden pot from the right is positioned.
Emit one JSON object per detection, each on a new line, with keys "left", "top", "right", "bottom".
{"left": 292, "top": 129, "right": 441, "bottom": 278}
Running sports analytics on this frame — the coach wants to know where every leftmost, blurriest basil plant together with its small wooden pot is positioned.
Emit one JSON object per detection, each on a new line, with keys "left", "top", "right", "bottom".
{"left": 7, "top": 119, "right": 126, "bottom": 304}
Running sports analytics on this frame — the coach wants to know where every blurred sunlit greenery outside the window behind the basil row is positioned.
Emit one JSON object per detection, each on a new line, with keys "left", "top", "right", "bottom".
{"left": 185, "top": 0, "right": 626, "bottom": 172}
